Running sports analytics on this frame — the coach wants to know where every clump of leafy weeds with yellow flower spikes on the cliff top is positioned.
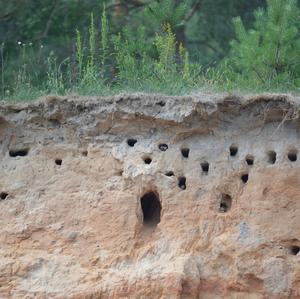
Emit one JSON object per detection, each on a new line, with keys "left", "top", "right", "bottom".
{"left": 113, "top": 20, "right": 195, "bottom": 91}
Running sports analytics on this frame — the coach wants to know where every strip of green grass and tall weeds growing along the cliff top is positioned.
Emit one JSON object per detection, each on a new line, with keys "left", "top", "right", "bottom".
{"left": 0, "top": 4, "right": 300, "bottom": 101}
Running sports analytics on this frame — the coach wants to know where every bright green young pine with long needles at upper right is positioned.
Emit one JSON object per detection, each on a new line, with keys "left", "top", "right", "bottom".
{"left": 228, "top": 0, "right": 300, "bottom": 87}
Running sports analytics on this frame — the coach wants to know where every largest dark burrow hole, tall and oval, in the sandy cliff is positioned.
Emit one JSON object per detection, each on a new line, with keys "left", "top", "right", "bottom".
{"left": 141, "top": 191, "right": 161, "bottom": 227}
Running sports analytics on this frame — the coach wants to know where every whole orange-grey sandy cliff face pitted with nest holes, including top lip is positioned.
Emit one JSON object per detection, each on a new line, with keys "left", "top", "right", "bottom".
{"left": 0, "top": 95, "right": 300, "bottom": 299}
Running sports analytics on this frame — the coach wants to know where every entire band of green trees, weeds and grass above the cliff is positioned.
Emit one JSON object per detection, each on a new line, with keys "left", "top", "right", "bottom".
{"left": 0, "top": 0, "right": 300, "bottom": 99}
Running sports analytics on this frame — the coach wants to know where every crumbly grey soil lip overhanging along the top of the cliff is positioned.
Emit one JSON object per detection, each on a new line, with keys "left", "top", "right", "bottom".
{"left": 0, "top": 93, "right": 300, "bottom": 122}
